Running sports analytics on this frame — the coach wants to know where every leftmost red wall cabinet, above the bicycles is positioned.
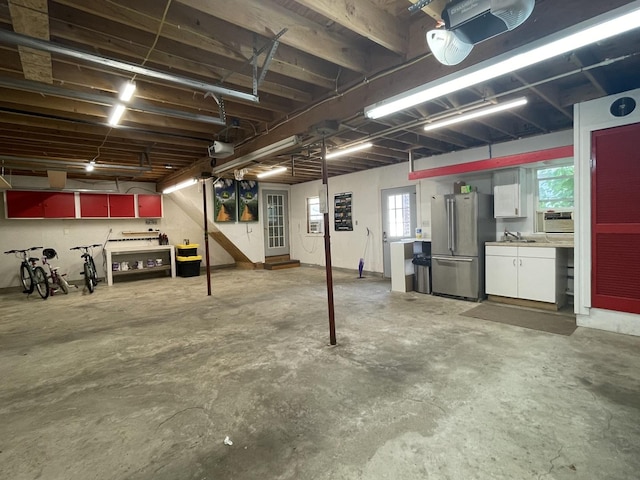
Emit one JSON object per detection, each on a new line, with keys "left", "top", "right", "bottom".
{"left": 5, "top": 190, "right": 76, "bottom": 218}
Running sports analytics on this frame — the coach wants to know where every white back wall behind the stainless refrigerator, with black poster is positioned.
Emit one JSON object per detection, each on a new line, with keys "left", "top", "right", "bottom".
{"left": 290, "top": 132, "right": 573, "bottom": 273}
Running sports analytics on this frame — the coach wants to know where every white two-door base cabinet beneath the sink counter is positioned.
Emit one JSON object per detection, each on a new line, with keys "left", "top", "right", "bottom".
{"left": 485, "top": 245, "right": 567, "bottom": 307}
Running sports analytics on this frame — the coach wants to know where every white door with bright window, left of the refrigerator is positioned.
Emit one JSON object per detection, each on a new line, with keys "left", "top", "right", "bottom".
{"left": 381, "top": 185, "right": 416, "bottom": 278}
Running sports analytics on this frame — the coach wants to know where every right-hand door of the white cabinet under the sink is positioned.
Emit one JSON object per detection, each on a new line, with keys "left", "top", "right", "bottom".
{"left": 518, "top": 255, "right": 556, "bottom": 303}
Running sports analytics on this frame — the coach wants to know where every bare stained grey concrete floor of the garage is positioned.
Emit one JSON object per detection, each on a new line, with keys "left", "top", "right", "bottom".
{"left": 0, "top": 267, "right": 640, "bottom": 480}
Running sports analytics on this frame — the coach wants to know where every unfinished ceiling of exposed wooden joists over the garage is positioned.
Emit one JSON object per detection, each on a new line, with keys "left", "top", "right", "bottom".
{"left": 0, "top": 0, "right": 640, "bottom": 186}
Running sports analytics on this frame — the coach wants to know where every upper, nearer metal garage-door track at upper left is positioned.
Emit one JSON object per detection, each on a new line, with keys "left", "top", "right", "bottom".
{"left": 0, "top": 30, "right": 259, "bottom": 103}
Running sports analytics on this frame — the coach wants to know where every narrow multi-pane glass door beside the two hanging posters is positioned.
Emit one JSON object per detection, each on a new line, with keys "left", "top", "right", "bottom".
{"left": 262, "top": 190, "right": 289, "bottom": 257}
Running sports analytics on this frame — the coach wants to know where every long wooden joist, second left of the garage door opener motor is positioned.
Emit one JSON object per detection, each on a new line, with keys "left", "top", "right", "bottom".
{"left": 176, "top": 0, "right": 369, "bottom": 73}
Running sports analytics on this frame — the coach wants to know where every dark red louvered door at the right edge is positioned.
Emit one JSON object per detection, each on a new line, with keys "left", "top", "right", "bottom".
{"left": 591, "top": 123, "right": 640, "bottom": 314}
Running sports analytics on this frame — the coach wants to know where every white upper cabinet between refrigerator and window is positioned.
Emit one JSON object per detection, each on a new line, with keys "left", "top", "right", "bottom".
{"left": 493, "top": 168, "right": 527, "bottom": 218}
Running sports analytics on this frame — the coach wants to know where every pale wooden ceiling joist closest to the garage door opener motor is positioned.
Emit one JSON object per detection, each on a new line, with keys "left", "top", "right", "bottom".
{"left": 295, "top": 0, "right": 407, "bottom": 56}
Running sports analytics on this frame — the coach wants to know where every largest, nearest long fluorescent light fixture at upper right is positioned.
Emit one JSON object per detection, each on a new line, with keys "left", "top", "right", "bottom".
{"left": 365, "top": 1, "right": 640, "bottom": 119}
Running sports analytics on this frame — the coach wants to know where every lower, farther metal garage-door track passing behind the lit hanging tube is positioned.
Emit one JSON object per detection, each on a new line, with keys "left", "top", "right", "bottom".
{"left": 0, "top": 78, "right": 226, "bottom": 125}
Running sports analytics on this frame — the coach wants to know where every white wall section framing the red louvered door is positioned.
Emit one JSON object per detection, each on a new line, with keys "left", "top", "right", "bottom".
{"left": 574, "top": 89, "right": 640, "bottom": 335}
